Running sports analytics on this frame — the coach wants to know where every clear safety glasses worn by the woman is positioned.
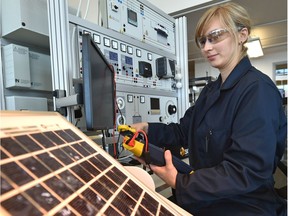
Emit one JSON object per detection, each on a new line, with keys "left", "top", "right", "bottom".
{"left": 197, "top": 29, "right": 229, "bottom": 49}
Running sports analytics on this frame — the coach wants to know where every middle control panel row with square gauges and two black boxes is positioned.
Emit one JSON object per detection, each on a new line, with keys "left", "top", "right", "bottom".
{"left": 78, "top": 26, "right": 176, "bottom": 92}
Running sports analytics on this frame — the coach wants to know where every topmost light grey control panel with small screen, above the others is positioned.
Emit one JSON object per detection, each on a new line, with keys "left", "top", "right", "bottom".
{"left": 102, "top": 0, "right": 176, "bottom": 54}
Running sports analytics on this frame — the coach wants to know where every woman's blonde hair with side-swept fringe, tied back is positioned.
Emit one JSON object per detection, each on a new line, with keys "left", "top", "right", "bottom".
{"left": 195, "top": 2, "right": 251, "bottom": 58}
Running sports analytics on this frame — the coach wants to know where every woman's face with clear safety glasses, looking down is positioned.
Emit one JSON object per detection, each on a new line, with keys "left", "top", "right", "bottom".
{"left": 198, "top": 18, "right": 241, "bottom": 72}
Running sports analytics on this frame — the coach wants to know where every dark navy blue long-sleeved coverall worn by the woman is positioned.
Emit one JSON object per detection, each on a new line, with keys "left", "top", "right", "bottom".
{"left": 148, "top": 57, "right": 287, "bottom": 216}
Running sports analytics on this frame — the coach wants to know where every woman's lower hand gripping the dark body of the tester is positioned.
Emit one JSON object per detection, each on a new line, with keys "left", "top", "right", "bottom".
{"left": 150, "top": 150, "right": 178, "bottom": 189}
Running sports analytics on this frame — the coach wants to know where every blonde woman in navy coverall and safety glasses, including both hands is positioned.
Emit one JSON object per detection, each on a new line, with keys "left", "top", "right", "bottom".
{"left": 131, "top": 2, "right": 287, "bottom": 216}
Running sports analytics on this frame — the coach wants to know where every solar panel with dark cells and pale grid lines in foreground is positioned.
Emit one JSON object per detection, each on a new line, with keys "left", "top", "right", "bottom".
{"left": 0, "top": 111, "right": 188, "bottom": 216}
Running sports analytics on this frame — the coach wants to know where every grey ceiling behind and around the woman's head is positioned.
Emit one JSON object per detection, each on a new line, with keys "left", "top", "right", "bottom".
{"left": 169, "top": 0, "right": 287, "bottom": 61}
